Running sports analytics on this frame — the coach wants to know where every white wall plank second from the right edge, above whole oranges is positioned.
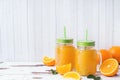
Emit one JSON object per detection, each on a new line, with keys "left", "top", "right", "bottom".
{"left": 105, "top": 0, "right": 114, "bottom": 49}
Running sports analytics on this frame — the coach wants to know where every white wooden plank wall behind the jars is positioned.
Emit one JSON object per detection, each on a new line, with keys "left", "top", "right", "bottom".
{"left": 0, "top": 0, "right": 120, "bottom": 61}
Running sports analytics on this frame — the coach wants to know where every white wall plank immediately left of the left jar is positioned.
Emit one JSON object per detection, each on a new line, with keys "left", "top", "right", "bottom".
{"left": 40, "top": 0, "right": 56, "bottom": 57}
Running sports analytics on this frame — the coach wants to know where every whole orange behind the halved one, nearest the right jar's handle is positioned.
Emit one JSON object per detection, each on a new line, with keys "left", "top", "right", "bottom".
{"left": 99, "top": 49, "right": 112, "bottom": 62}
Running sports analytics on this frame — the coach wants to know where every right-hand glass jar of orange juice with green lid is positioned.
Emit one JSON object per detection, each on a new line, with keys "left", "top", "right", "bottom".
{"left": 75, "top": 41, "right": 97, "bottom": 76}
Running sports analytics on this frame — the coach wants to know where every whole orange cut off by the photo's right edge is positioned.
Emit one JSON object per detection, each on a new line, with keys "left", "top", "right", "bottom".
{"left": 109, "top": 46, "right": 120, "bottom": 63}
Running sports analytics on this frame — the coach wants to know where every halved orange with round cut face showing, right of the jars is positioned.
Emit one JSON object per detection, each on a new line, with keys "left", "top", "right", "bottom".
{"left": 100, "top": 58, "right": 119, "bottom": 76}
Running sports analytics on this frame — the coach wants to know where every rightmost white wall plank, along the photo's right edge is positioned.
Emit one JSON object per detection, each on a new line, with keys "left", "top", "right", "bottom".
{"left": 113, "top": 0, "right": 120, "bottom": 45}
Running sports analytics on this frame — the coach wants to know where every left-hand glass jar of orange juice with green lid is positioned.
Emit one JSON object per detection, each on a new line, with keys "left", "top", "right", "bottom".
{"left": 55, "top": 39, "right": 75, "bottom": 69}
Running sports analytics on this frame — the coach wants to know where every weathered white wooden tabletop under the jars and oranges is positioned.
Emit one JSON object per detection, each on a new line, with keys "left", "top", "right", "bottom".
{"left": 0, "top": 62, "right": 120, "bottom": 80}
